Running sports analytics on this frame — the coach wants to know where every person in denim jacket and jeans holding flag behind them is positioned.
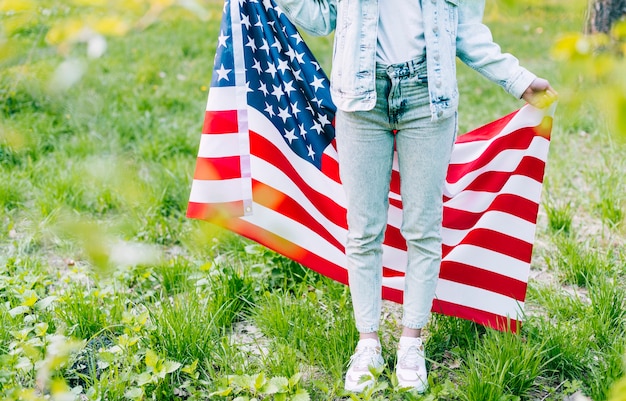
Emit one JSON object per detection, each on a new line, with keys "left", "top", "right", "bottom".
{"left": 278, "top": 0, "right": 556, "bottom": 392}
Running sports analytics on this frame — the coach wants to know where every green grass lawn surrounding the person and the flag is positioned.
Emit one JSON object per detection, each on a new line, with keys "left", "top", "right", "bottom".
{"left": 0, "top": 0, "right": 626, "bottom": 401}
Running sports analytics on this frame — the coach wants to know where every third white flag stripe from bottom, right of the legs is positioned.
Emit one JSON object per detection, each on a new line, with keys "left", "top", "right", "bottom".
{"left": 441, "top": 211, "right": 535, "bottom": 246}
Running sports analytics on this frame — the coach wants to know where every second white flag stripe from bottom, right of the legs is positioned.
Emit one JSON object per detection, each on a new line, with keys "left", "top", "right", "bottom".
{"left": 443, "top": 245, "right": 530, "bottom": 283}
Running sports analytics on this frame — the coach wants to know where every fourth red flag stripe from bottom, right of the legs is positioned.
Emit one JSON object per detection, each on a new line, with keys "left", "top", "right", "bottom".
{"left": 443, "top": 194, "right": 539, "bottom": 230}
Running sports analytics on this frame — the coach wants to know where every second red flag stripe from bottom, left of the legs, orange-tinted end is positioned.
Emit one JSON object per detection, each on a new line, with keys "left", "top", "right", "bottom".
{"left": 252, "top": 180, "right": 345, "bottom": 252}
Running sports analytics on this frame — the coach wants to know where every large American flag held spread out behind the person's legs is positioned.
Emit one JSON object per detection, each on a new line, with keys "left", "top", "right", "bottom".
{"left": 187, "top": 0, "right": 552, "bottom": 330}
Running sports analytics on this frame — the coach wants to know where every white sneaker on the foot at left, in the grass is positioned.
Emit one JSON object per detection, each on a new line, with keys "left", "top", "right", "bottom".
{"left": 344, "top": 338, "right": 385, "bottom": 393}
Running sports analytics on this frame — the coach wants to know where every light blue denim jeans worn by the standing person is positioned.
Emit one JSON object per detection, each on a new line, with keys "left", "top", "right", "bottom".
{"left": 335, "top": 56, "right": 456, "bottom": 333}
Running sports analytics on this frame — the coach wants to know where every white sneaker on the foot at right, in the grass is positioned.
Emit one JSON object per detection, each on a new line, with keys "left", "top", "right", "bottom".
{"left": 396, "top": 338, "right": 428, "bottom": 393}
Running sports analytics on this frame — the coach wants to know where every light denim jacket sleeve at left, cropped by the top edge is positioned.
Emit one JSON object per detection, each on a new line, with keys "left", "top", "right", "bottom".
{"left": 276, "top": 0, "right": 337, "bottom": 36}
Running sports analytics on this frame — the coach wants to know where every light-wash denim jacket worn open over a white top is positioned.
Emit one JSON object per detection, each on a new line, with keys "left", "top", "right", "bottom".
{"left": 277, "top": 0, "right": 536, "bottom": 120}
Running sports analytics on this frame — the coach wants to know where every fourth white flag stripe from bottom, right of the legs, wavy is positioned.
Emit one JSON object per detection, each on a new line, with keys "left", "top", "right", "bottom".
{"left": 443, "top": 175, "right": 542, "bottom": 213}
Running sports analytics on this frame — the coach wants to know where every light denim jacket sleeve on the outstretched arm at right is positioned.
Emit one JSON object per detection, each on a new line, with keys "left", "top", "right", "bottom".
{"left": 456, "top": 0, "right": 537, "bottom": 99}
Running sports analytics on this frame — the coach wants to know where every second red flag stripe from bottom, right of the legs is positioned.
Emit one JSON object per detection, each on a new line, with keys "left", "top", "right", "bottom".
{"left": 439, "top": 260, "right": 526, "bottom": 301}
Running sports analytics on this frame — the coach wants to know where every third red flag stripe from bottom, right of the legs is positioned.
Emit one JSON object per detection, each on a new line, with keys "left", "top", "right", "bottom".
{"left": 442, "top": 228, "right": 533, "bottom": 263}
